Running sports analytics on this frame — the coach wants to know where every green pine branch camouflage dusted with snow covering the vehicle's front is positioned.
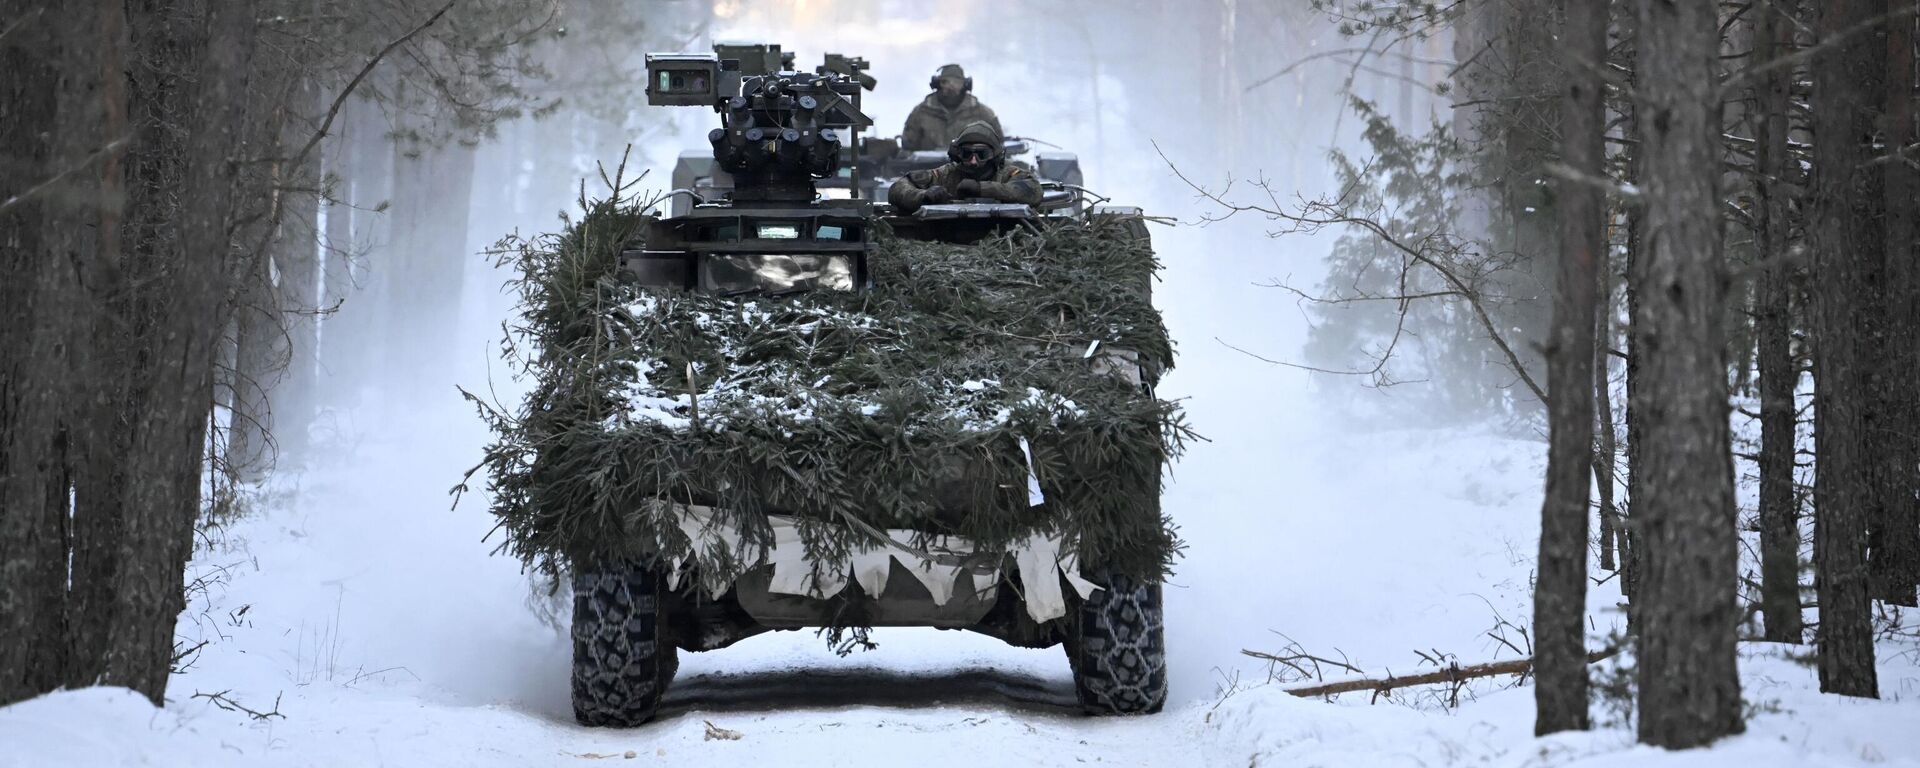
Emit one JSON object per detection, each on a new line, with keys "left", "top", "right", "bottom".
{"left": 468, "top": 190, "right": 1192, "bottom": 582}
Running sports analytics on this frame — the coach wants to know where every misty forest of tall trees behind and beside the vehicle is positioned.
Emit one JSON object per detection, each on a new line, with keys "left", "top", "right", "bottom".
{"left": 0, "top": 0, "right": 1920, "bottom": 747}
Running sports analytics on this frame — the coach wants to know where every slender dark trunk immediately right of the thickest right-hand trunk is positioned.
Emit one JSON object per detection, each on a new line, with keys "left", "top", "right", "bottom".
{"left": 1753, "top": 6, "right": 1801, "bottom": 643}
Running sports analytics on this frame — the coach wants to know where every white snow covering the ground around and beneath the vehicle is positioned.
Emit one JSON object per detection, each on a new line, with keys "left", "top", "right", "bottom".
{"left": 11, "top": 384, "right": 1920, "bottom": 768}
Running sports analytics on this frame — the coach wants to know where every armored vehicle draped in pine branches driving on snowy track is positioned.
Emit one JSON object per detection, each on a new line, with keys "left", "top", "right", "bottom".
{"left": 541, "top": 44, "right": 1185, "bottom": 726}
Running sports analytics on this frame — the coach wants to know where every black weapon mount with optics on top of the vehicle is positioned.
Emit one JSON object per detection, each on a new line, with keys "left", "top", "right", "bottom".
{"left": 647, "top": 44, "right": 877, "bottom": 205}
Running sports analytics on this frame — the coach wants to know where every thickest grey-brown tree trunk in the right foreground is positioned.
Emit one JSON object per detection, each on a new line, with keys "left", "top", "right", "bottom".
{"left": 1632, "top": 0, "right": 1743, "bottom": 749}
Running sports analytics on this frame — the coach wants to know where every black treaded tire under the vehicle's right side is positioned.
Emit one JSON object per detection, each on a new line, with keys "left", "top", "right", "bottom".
{"left": 1066, "top": 576, "right": 1167, "bottom": 714}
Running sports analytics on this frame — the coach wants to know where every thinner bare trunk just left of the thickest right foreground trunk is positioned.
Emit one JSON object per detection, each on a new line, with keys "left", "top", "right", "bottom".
{"left": 1534, "top": 2, "right": 1607, "bottom": 735}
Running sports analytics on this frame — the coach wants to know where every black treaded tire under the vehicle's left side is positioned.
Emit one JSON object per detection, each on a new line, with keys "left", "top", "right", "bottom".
{"left": 574, "top": 564, "right": 680, "bottom": 728}
